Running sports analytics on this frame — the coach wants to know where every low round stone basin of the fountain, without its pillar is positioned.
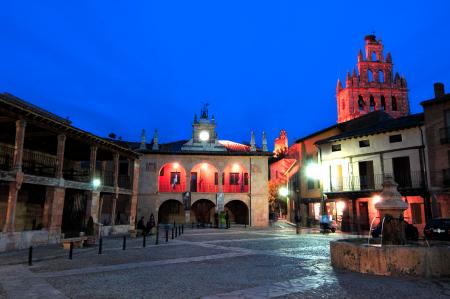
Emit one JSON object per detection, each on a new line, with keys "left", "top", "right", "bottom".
{"left": 330, "top": 239, "right": 450, "bottom": 277}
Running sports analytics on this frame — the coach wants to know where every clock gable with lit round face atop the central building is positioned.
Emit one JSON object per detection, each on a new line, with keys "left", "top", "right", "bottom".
{"left": 181, "top": 104, "right": 226, "bottom": 151}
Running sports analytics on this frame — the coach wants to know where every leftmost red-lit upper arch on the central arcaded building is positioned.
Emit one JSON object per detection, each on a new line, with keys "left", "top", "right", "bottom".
{"left": 158, "top": 161, "right": 186, "bottom": 192}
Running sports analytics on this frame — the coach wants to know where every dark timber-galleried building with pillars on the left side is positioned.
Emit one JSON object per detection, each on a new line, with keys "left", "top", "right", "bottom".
{"left": 0, "top": 94, "right": 139, "bottom": 251}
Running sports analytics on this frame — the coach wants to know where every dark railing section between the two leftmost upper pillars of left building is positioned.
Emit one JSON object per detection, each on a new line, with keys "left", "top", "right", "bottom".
{"left": 22, "top": 149, "right": 58, "bottom": 177}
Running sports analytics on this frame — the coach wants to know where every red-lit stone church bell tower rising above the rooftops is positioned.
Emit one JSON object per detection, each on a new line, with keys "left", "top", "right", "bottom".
{"left": 336, "top": 35, "right": 409, "bottom": 123}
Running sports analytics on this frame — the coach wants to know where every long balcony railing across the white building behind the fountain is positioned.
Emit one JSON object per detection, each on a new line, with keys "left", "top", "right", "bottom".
{"left": 323, "top": 171, "right": 425, "bottom": 193}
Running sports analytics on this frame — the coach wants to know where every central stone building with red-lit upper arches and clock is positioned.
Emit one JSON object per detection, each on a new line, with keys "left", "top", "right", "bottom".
{"left": 132, "top": 107, "right": 271, "bottom": 226}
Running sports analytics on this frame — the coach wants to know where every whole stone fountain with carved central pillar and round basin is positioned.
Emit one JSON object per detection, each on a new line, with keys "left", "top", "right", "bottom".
{"left": 330, "top": 176, "right": 450, "bottom": 277}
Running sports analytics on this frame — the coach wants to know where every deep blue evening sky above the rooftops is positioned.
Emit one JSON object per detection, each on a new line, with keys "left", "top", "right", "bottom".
{"left": 0, "top": 0, "right": 450, "bottom": 146}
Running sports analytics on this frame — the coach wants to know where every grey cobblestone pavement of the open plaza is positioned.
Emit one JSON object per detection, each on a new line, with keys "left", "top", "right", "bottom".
{"left": 0, "top": 224, "right": 450, "bottom": 298}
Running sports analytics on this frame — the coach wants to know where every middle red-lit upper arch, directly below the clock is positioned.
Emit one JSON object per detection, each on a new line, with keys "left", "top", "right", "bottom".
{"left": 189, "top": 161, "right": 219, "bottom": 193}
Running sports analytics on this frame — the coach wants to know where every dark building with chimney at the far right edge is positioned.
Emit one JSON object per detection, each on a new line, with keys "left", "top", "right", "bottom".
{"left": 421, "top": 83, "right": 450, "bottom": 217}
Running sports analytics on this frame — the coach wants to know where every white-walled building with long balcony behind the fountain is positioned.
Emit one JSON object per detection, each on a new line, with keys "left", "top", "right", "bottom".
{"left": 316, "top": 111, "right": 431, "bottom": 232}
